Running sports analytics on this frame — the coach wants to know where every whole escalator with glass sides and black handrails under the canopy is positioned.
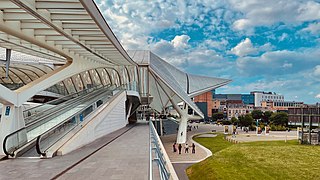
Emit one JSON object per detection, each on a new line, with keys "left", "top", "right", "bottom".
{"left": 3, "top": 86, "right": 120, "bottom": 157}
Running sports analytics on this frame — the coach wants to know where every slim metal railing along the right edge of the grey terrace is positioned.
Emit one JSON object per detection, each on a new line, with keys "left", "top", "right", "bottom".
{"left": 149, "top": 121, "right": 171, "bottom": 180}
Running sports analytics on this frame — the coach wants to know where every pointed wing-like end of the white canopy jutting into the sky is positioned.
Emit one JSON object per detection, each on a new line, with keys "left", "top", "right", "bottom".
{"left": 128, "top": 50, "right": 231, "bottom": 116}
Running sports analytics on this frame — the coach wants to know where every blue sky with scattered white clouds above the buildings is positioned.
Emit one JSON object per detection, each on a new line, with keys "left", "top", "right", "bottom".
{"left": 96, "top": 0, "right": 320, "bottom": 103}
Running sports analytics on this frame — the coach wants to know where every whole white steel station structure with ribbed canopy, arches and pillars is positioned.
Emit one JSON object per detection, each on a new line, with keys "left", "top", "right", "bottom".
{"left": 0, "top": 0, "right": 230, "bottom": 154}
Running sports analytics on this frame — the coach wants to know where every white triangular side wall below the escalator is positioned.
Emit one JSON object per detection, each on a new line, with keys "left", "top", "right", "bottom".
{"left": 58, "top": 92, "right": 128, "bottom": 155}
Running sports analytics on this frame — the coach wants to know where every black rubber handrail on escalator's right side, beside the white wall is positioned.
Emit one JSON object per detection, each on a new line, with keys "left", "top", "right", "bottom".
{"left": 36, "top": 86, "right": 122, "bottom": 156}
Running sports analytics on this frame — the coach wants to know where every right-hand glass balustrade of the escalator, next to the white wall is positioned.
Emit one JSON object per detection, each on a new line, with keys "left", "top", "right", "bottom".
{"left": 36, "top": 87, "right": 122, "bottom": 156}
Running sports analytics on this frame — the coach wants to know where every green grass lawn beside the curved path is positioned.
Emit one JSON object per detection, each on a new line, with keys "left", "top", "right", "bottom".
{"left": 187, "top": 135, "right": 320, "bottom": 180}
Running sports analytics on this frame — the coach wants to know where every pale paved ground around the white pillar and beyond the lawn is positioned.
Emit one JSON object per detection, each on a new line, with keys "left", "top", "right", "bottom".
{"left": 161, "top": 123, "right": 297, "bottom": 180}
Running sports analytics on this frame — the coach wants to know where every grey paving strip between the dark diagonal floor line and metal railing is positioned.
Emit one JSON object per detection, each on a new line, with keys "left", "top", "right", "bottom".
{"left": 59, "top": 125, "right": 149, "bottom": 180}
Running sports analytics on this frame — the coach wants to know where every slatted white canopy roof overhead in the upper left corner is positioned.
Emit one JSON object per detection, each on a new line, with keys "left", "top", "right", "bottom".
{"left": 0, "top": 0, "right": 134, "bottom": 65}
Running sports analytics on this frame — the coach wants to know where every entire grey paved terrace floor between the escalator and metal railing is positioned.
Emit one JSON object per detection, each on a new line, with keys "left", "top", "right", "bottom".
{"left": 0, "top": 124, "right": 149, "bottom": 180}
